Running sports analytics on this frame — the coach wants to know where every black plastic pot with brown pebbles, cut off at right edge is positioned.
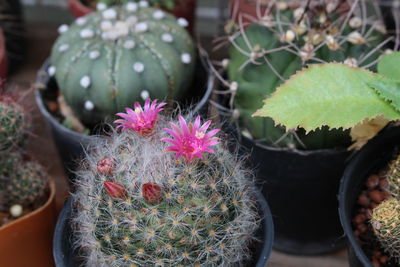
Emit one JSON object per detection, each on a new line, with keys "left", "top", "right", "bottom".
{"left": 339, "top": 126, "right": 400, "bottom": 267}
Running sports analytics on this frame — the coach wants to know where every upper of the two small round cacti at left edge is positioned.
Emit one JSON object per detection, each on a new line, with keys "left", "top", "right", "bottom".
{"left": 0, "top": 97, "right": 30, "bottom": 150}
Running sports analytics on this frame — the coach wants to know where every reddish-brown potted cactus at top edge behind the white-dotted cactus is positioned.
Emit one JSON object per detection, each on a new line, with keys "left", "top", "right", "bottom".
{"left": 68, "top": 0, "right": 196, "bottom": 33}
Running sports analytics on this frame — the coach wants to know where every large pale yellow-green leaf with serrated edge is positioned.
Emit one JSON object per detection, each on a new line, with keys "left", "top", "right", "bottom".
{"left": 253, "top": 63, "right": 400, "bottom": 132}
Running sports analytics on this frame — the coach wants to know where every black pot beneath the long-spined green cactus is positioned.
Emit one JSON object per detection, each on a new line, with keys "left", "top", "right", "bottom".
{"left": 212, "top": 86, "right": 350, "bottom": 255}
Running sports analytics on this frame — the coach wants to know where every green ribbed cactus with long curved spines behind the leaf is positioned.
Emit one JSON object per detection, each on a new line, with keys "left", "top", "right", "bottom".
{"left": 225, "top": 0, "right": 391, "bottom": 149}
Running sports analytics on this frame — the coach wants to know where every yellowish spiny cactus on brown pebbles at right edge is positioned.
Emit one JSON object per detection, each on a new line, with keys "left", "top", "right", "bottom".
{"left": 371, "top": 156, "right": 400, "bottom": 264}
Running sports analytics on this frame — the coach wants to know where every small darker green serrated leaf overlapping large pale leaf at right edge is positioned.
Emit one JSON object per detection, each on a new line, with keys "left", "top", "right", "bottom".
{"left": 368, "top": 79, "right": 400, "bottom": 112}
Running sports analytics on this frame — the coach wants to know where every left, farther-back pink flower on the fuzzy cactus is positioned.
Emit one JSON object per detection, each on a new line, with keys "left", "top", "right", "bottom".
{"left": 114, "top": 98, "right": 167, "bottom": 136}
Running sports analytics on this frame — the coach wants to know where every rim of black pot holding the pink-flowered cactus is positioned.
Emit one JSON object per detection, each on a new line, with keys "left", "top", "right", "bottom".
{"left": 53, "top": 190, "right": 275, "bottom": 267}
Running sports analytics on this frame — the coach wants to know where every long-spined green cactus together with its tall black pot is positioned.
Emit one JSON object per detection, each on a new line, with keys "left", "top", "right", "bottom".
{"left": 212, "top": 0, "right": 394, "bottom": 254}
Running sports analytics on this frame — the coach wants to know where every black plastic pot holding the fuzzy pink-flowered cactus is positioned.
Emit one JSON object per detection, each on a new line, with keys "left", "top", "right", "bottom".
{"left": 53, "top": 193, "right": 274, "bottom": 267}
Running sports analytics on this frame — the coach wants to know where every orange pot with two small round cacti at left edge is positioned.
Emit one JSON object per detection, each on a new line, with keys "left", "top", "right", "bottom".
{"left": 0, "top": 95, "right": 55, "bottom": 267}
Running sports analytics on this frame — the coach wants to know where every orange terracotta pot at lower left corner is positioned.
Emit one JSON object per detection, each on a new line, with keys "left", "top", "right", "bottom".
{"left": 0, "top": 181, "right": 56, "bottom": 267}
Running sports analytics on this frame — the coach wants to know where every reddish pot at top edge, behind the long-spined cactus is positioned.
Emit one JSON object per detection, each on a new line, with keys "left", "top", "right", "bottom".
{"left": 229, "top": 0, "right": 266, "bottom": 23}
